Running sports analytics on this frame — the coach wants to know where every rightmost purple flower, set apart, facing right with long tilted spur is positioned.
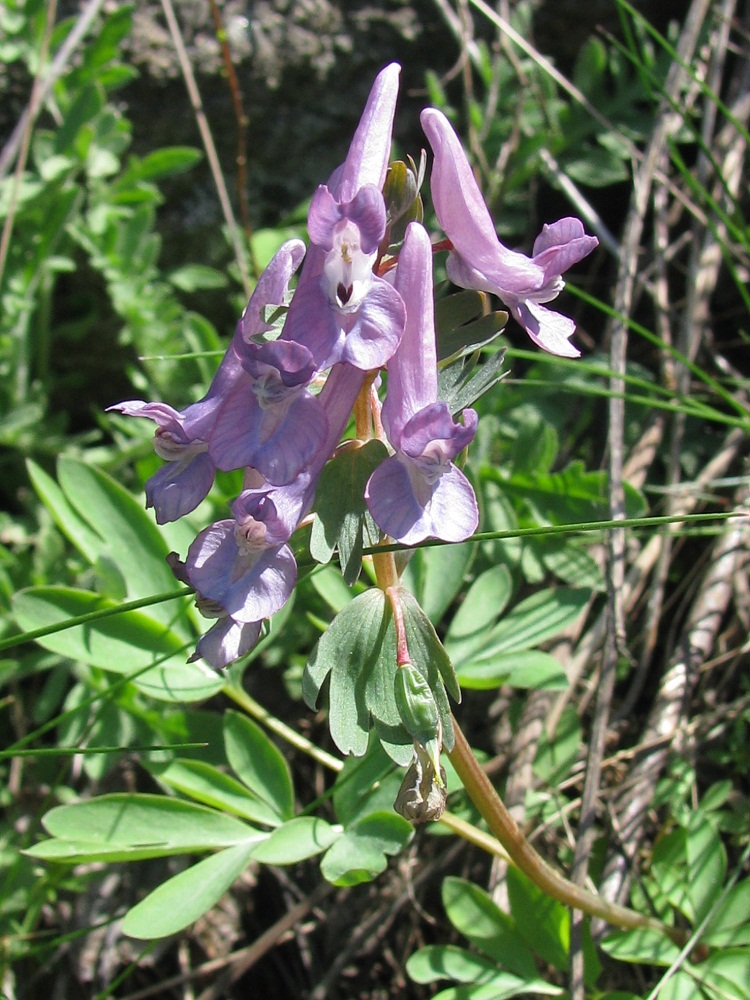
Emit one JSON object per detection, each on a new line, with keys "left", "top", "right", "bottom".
{"left": 421, "top": 108, "right": 599, "bottom": 358}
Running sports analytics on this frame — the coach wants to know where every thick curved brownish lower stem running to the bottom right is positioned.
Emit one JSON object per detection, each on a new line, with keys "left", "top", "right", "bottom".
{"left": 448, "top": 719, "right": 688, "bottom": 945}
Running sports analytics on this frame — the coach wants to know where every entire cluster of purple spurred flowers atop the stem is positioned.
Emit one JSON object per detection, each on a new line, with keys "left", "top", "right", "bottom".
{"left": 111, "top": 64, "right": 597, "bottom": 669}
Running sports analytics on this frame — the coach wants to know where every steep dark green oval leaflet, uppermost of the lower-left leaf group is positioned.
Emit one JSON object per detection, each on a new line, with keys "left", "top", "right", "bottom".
{"left": 224, "top": 712, "right": 294, "bottom": 820}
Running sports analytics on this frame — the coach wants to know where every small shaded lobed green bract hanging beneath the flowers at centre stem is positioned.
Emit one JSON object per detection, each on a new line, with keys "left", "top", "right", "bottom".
{"left": 310, "top": 441, "right": 388, "bottom": 586}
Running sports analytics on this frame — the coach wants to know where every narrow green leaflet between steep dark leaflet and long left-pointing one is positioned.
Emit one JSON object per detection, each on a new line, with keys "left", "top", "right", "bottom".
{"left": 147, "top": 759, "right": 282, "bottom": 826}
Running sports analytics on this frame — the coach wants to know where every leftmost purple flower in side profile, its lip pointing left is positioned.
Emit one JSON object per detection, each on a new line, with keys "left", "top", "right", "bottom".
{"left": 108, "top": 240, "right": 305, "bottom": 524}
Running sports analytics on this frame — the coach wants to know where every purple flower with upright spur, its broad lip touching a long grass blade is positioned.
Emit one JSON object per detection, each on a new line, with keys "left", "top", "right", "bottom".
{"left": 365, "top": 222, "right": 479, "bottom": 545}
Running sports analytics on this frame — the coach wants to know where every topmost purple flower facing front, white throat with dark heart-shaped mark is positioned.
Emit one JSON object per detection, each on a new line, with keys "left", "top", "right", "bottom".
{"left": 282, "top": 63, "right": 405, "bottom": 371}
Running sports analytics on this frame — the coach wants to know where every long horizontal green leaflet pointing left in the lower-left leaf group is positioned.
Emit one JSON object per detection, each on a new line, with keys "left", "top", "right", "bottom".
{"left": 28, "top": 793, "right": 258, "bottom": 862}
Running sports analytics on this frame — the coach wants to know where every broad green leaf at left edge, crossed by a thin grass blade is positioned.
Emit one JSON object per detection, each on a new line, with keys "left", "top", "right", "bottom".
{"left": 13, "top": 587, "right": 224, "bottom": 701}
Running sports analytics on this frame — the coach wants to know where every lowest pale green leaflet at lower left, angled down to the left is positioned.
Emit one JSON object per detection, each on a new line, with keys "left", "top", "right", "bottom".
{"left": 122, "top": 844, "right": 253, "bottom": 940}
